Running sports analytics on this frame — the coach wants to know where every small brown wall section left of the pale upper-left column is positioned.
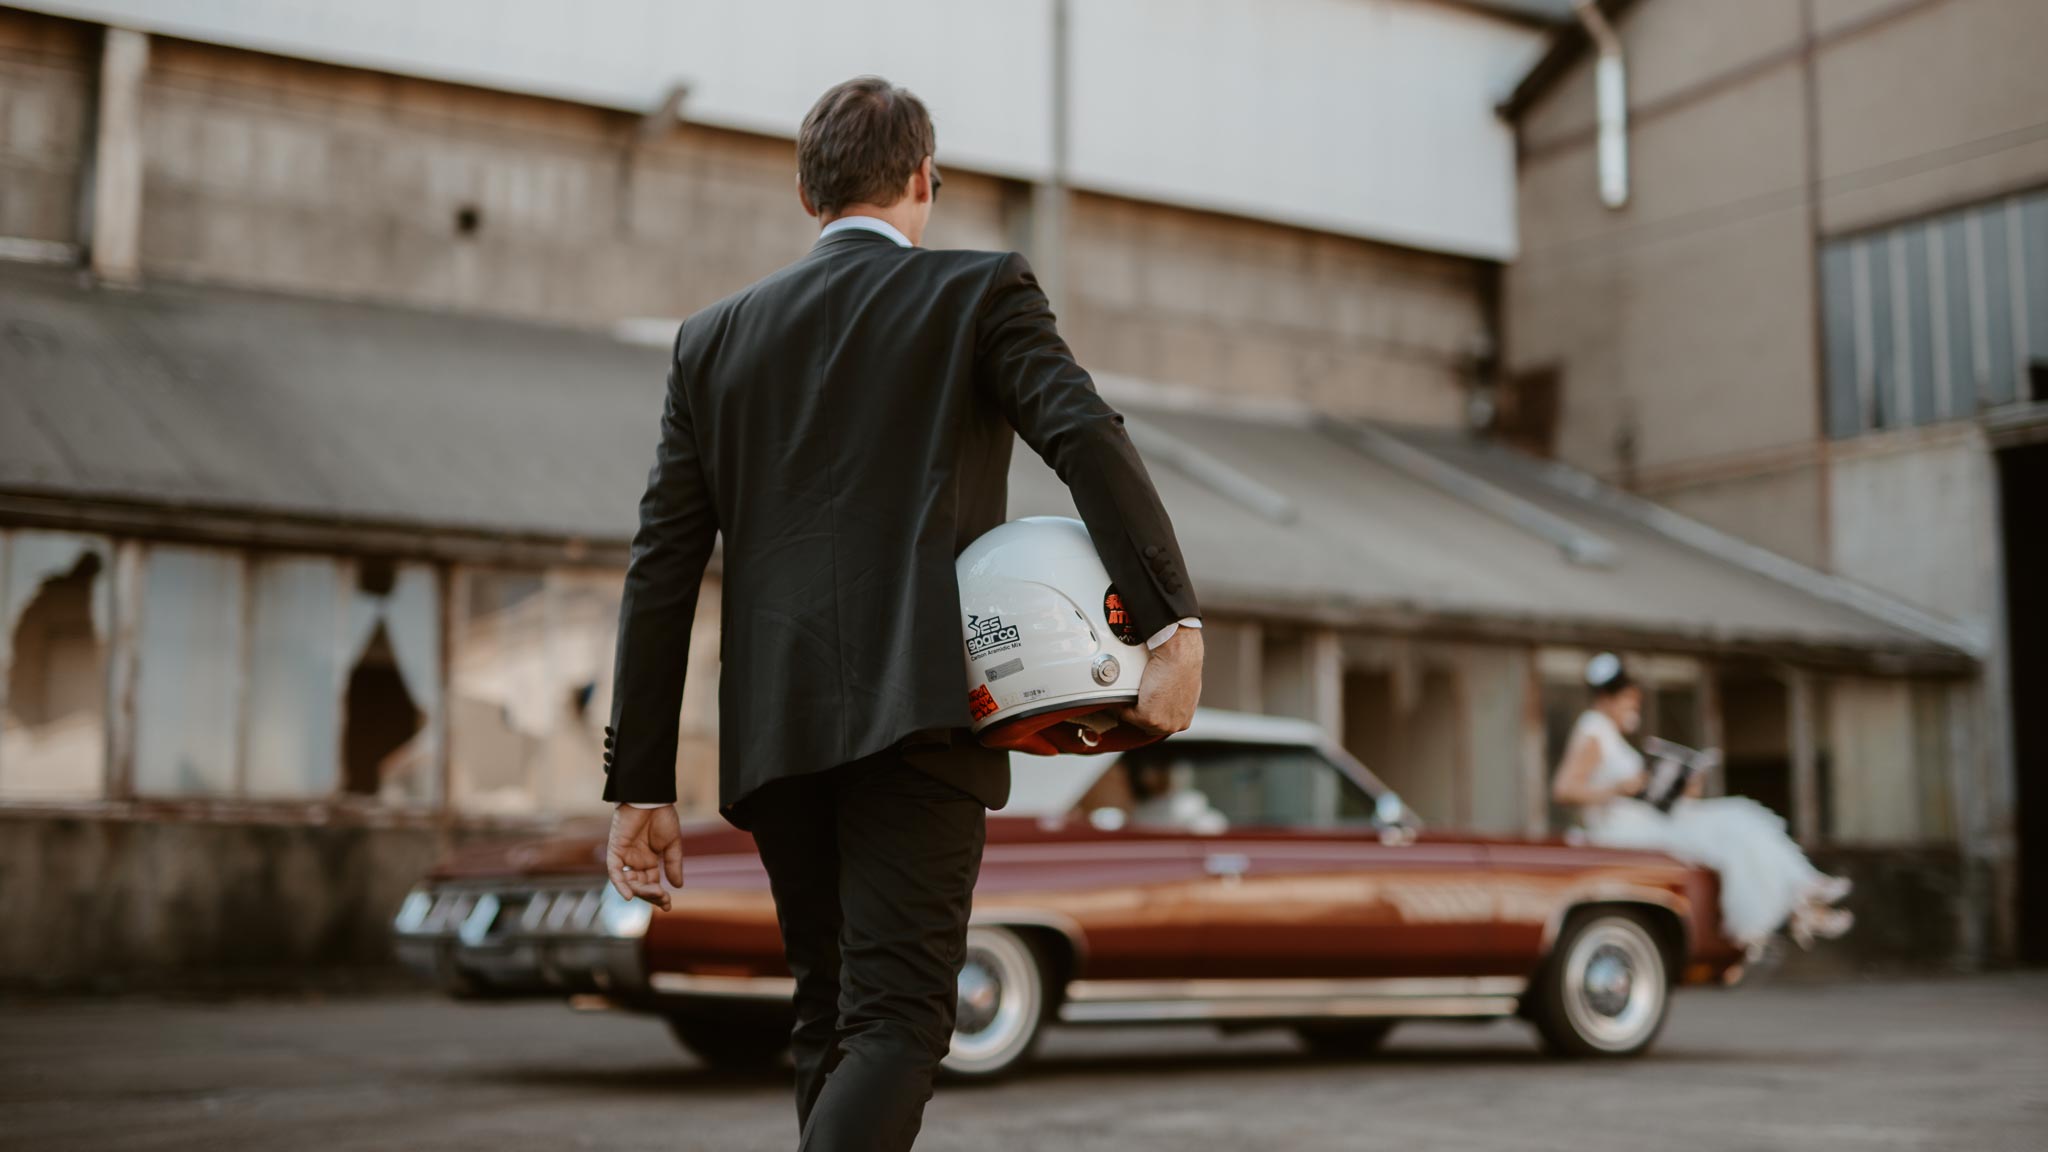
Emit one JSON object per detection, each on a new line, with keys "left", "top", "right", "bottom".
{"left": 0, "top": 8, "right": 98, "bottom": 244}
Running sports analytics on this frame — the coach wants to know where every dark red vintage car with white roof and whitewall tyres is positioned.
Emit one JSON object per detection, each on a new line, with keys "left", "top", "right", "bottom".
{"left": 395, "top": 711, "right": 1741, "bottom": 1076}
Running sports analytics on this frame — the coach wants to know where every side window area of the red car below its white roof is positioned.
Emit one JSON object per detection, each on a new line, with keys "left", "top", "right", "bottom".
{"left": 1079, "top": 742, "right": 1372, "bottom": 834}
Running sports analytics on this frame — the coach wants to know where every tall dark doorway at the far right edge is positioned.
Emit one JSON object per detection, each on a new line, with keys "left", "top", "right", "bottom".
{"left": 1993, "top": 443, "right": 2048, "bottom": 963}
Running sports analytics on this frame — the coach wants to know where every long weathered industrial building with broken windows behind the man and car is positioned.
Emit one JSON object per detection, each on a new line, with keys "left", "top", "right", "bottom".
{"left": 0, "top": 0, "right": 2015, "bottom": 986}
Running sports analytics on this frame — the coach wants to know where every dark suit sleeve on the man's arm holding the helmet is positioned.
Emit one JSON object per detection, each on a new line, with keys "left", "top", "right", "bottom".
{"left": 975, "top": 252, "right": 1202, "bottom": 637}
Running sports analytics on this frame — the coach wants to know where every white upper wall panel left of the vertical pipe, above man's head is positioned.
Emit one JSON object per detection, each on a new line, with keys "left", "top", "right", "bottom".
{"left": 23, "top": 0, "right": 1053, "bottom": 178}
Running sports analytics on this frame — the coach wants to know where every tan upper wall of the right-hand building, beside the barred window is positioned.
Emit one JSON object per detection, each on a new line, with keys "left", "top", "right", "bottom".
{"left": 1505, "top": 0, "right": 2048, "bottom": 557}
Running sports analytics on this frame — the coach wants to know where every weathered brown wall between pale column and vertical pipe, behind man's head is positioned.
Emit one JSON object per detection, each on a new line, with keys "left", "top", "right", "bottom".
{"left": 141, "top": 41, "right": 1008, "bottom": 324}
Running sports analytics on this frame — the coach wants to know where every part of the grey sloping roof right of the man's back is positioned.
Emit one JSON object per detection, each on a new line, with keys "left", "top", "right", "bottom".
{"left": 1010, "top": 404, "right": 1980, "bottom": 672}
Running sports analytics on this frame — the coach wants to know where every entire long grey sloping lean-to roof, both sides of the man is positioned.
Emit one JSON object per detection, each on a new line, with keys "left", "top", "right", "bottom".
{"left": 0, "top": 264, "right": 1980, "bottom": 672}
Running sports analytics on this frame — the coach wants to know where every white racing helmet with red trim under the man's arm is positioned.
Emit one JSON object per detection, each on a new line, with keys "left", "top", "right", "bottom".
{"left": 954, "top": 517, "right": 1153, "bottom": 756}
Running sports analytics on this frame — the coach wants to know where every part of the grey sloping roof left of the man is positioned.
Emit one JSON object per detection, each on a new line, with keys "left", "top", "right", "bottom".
{"left": 0, "top": 264, "right": 666, "bottom": 558}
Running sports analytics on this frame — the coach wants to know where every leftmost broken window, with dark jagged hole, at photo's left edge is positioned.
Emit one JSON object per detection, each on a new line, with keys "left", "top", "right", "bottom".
{"left": 0, "top": 531, "right": 113, "bottom": 799}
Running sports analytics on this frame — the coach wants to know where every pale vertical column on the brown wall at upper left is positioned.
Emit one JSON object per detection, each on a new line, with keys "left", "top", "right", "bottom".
{"left": 92, "top": 29, "right": 150, "bottom": 285}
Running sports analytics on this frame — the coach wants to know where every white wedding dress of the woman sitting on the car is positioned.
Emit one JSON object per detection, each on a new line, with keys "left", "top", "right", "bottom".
{"left": 1573, "top": 709, "right": 1845, "bottom": 951}
